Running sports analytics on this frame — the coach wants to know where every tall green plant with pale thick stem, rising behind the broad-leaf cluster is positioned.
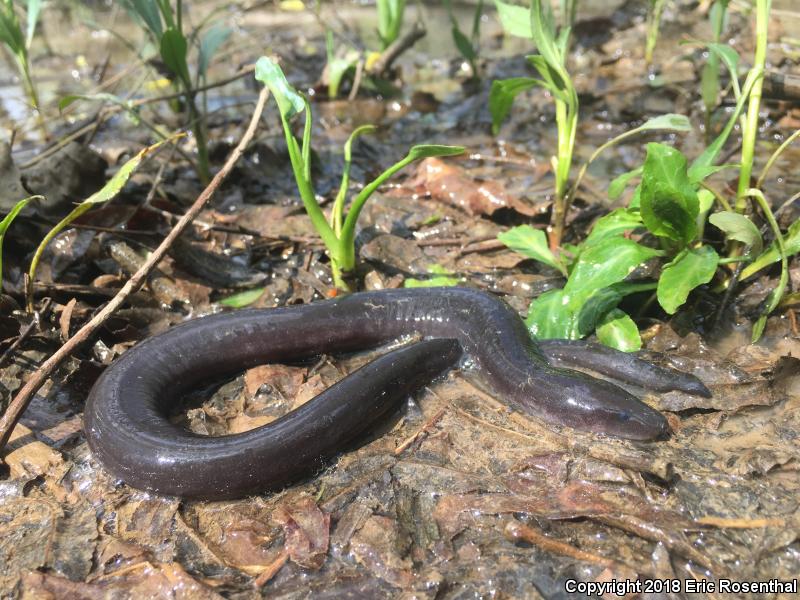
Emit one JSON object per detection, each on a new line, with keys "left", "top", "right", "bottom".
{"left": 489, "top": 0, "right": 578, "bottom": 248}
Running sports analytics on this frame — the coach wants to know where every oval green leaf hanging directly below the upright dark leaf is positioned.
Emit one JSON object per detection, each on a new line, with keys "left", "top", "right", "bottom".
{"left": 656, "top": 246, "right": 719, "bottom": 315}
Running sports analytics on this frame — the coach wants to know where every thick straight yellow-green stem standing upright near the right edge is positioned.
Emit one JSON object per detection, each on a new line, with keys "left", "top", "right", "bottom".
{"left": 736, "top": 0, "right": 771, "bottom": 213}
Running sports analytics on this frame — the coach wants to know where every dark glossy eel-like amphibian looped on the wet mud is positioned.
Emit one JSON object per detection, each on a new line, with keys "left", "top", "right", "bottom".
{"left": 84, "top": 288, "right": 708, "bottom": 499}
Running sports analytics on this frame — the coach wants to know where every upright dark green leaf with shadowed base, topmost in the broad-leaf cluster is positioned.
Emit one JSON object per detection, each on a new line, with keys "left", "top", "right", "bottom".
{"left": 640, "top": 143, "right": 700, "bottom": 245}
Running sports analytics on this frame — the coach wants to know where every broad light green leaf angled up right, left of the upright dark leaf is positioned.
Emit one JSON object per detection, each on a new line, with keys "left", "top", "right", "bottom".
{"left": 564, "top": 237, "right": 663, "bottom": 301}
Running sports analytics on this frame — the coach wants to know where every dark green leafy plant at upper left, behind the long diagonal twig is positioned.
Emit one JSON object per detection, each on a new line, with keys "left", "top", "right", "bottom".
{"left": 124, "top": 0, "right": 230, "bottom": 183}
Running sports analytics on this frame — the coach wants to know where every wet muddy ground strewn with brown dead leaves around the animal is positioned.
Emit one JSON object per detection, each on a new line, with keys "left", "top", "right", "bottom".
{"left": 0, "top": 0, "right": 800, "bottom": 599}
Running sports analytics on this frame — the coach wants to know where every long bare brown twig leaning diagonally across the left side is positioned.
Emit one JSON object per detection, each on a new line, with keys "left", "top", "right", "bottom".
{"left": 0, "top": 88, "right": 269, "bottom": 451}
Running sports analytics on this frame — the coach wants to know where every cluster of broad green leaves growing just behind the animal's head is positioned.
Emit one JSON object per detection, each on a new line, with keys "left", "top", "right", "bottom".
{"left": 500, "top": 137, "right": 720, "bottom": 351}
